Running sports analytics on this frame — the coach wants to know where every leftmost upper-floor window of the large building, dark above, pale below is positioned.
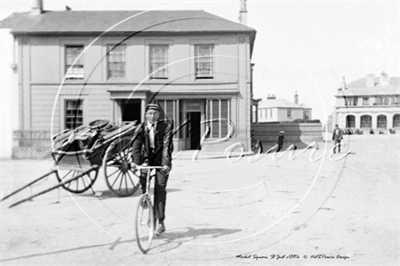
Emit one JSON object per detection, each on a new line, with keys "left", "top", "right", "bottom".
{"left": 65, "top": 45, "right": 85, "bottom": 79}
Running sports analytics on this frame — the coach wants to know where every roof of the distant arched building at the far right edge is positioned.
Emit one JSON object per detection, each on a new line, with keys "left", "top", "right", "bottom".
{"left": 336, "top": 77, "right": 400, "bottom": 97}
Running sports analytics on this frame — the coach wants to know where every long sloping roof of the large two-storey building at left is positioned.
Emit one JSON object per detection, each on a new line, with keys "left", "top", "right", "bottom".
{"left": 1, "top": 10, "right": 255, "bottom": 35}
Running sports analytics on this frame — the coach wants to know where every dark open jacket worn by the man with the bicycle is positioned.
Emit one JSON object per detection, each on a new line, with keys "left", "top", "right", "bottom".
{"left": 132, "top": 121, "right": 173, "bottom": 167}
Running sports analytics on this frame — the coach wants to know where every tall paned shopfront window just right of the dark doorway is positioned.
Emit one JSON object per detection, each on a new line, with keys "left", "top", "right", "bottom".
{"left": 206, "top": 99, "right": 231, "bottom": 138}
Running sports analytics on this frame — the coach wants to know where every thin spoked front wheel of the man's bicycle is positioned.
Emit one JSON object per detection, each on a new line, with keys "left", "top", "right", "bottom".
{"left": 135, "top": 195, "right": 154, "bottom": 253}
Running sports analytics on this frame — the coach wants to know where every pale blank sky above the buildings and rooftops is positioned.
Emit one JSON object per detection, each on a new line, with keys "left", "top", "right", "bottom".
{"left": 0, "top": 0, "right": 400, "bottom": 122}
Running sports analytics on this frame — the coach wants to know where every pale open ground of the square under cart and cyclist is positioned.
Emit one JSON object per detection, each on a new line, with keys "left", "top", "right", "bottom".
{"left": 0, "top": 135, "right": 400, "bottom": 265}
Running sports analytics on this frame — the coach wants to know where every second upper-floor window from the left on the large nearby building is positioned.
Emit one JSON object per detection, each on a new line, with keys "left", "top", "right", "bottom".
{"left": 107, "top": 45, "right": 126, "bottom": 79}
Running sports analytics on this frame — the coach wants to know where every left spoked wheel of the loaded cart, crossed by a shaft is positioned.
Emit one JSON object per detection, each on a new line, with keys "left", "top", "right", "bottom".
{"left": 56, "top": 166, "right": 99, "bottom": 194}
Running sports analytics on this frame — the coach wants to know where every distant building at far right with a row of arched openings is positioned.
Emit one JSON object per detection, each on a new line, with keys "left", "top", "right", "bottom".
{"left": 332, "top": 72, "right": 400, "bottom": 132}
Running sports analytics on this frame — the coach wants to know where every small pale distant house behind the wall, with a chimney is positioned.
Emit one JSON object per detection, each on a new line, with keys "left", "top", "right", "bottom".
{"left": 253, "top": 91, "right": 312, "bottom": 122}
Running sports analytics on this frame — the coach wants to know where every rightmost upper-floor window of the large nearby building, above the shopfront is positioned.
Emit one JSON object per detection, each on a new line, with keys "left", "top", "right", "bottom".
{"left": 195, "top": 44, "right": 214, "bottom": 78}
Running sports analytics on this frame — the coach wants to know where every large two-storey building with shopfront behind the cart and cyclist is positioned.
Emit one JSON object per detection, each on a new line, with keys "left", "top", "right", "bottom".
{"left": 2, "top": 1, "right": 256, "bottom": 151}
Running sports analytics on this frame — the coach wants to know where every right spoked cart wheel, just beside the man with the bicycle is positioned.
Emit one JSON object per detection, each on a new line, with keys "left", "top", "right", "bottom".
{"left": 103, "top": 137, "right": 140, "bottom": 197}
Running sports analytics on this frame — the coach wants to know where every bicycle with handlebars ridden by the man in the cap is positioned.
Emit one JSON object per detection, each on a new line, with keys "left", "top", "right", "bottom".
{"left": 134, "top": 166, "right": 163, "bottom": 253}
